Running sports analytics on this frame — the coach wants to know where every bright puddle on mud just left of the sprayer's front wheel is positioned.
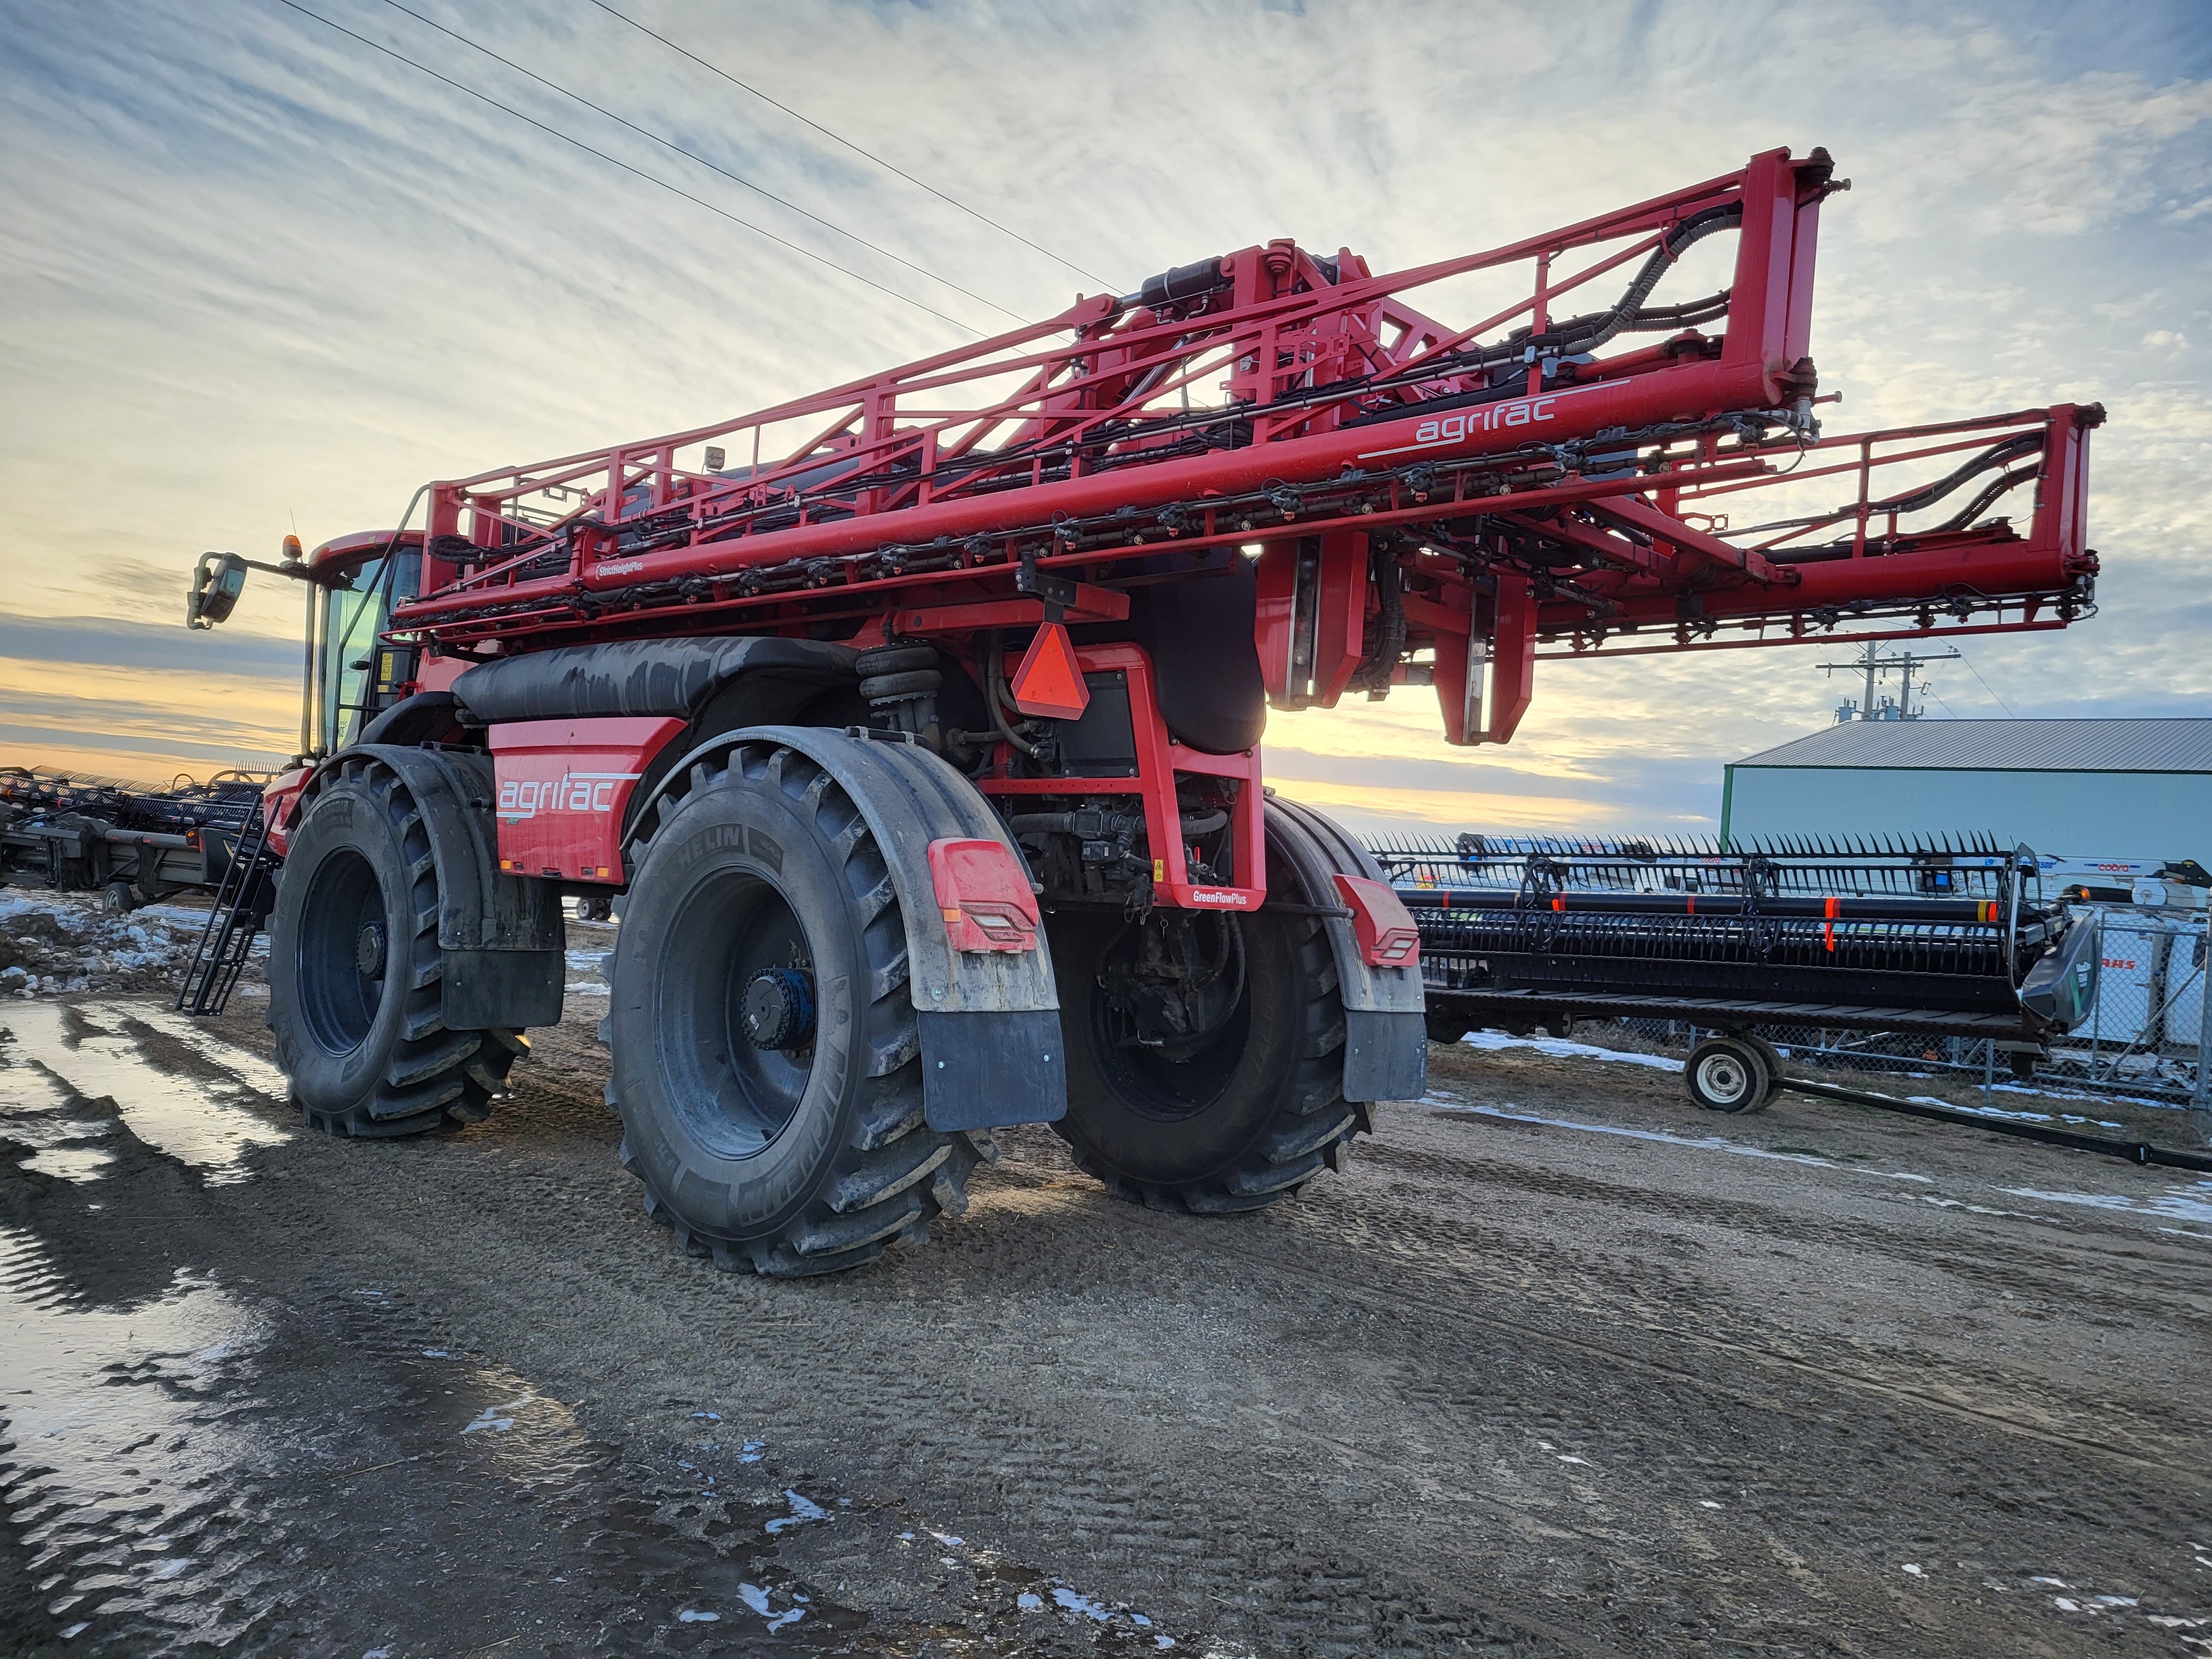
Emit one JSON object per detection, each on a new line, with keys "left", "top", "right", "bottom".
{"left": 0, "top": 1002, "right": 292, "bottom": 1186}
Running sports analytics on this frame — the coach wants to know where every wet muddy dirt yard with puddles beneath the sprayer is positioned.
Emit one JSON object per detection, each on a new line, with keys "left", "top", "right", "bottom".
{"left": 0, "top": 951, "right": 2212, "bottom": 1659}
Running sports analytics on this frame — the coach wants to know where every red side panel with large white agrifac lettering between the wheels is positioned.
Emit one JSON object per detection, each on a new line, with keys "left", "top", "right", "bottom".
{"left": 491, "top": 717, "right": 684, "bottom": 887}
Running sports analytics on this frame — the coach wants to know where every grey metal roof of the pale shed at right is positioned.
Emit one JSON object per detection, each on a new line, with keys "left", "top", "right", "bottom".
{"left": 1736, "top": 719, "right": 2212, "bottom": 772}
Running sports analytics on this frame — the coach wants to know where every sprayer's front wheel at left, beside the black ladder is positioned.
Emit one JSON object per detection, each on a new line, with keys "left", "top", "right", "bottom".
{"left": 268, "top": 759, "right": 529, "bottom": 1135}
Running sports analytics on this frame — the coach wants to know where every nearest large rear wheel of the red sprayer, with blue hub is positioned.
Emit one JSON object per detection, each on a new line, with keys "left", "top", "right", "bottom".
{"left": 606, "top": 741, "right": 991, "bottom": 1276}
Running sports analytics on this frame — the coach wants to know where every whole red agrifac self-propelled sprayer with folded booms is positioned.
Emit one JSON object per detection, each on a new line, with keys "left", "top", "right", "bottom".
{"left": 195, "top": 150, "right": 2099, "bottom": 1272}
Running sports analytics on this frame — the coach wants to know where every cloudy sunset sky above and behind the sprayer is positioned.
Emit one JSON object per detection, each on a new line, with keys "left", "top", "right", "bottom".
{"left": 0, "top": 0, "right": 2212, "bottom": 834}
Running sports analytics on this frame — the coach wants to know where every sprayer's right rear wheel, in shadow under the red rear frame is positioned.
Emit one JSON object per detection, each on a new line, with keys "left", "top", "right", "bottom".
{"left": 1051, "top": 909, "right": 1369, "bottom": 1214}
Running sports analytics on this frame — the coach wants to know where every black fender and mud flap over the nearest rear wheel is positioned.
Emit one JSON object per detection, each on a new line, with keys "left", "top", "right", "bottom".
{"left": 626, "top": 726, "right": 1068, "bottom": 1130}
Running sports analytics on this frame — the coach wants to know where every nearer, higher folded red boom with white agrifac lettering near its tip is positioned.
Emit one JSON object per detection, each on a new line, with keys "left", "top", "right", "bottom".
{"left": 394, "top": 150, "right": 1843, "bottom": 644}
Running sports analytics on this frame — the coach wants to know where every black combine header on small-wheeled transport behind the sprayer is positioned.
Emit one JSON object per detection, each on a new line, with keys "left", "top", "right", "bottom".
{"left": 1376, "top": 836, "right": 2099, "bottom": 1113}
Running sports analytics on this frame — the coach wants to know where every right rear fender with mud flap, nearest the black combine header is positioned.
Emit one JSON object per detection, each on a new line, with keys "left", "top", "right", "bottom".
{"left": 1267, "top": 794, "right": 1429, "bottom": 1099}
